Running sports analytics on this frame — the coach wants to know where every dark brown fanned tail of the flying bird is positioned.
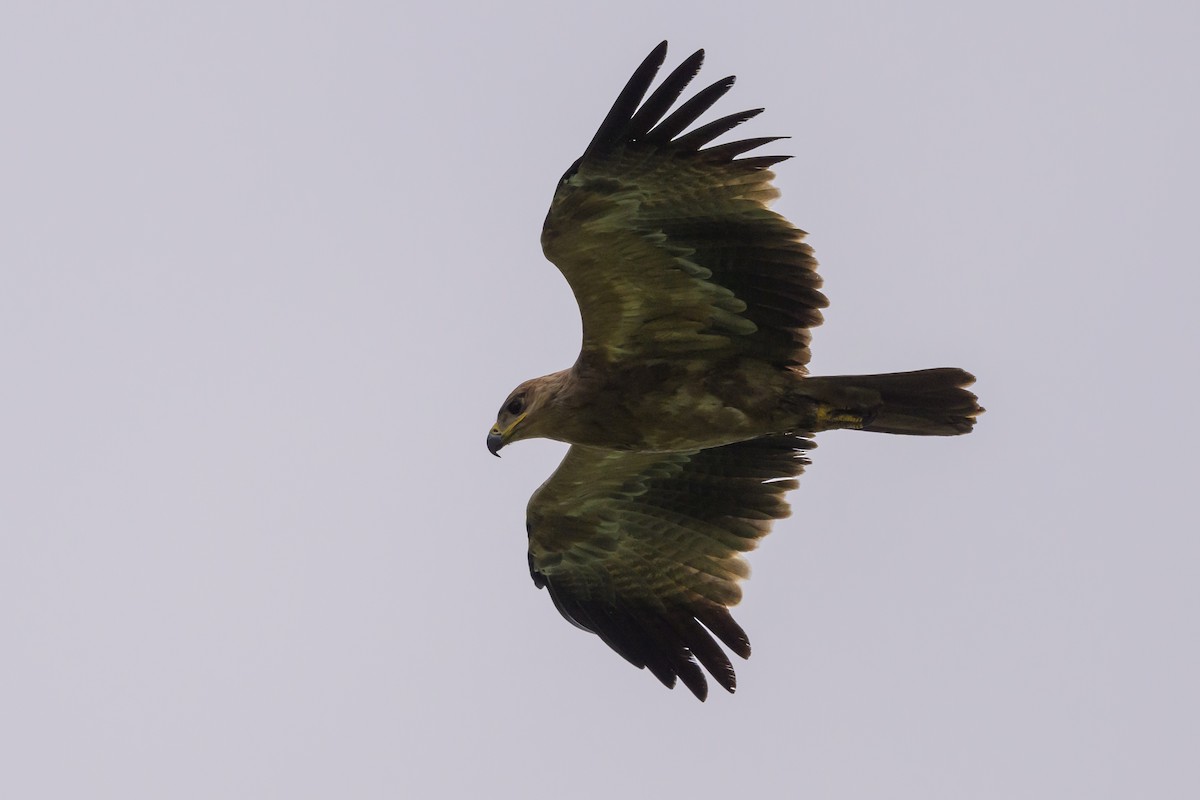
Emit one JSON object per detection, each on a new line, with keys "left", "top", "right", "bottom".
{"left": 808, "top": 367, "right": 984, "bottom": 437}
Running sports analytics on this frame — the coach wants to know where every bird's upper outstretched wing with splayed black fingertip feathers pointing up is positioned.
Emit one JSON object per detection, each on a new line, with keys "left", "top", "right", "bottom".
{"left": 541, "top": 42, "right": 828, "bottom": 368}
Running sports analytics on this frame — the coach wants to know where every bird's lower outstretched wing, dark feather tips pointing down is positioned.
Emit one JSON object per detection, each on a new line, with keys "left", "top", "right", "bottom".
{"left": 527, "top": 437, "right": 816, "bottom": 700}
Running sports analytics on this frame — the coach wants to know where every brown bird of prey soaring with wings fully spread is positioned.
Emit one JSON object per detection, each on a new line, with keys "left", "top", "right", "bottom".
{"left": 487, "top": 42, "right": 983, "bottom": 700}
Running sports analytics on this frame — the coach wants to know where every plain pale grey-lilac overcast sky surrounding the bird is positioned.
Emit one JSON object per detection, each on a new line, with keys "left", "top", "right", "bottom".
{"left": 0, "top": 0, "right": 1200, "bottom": 800}
